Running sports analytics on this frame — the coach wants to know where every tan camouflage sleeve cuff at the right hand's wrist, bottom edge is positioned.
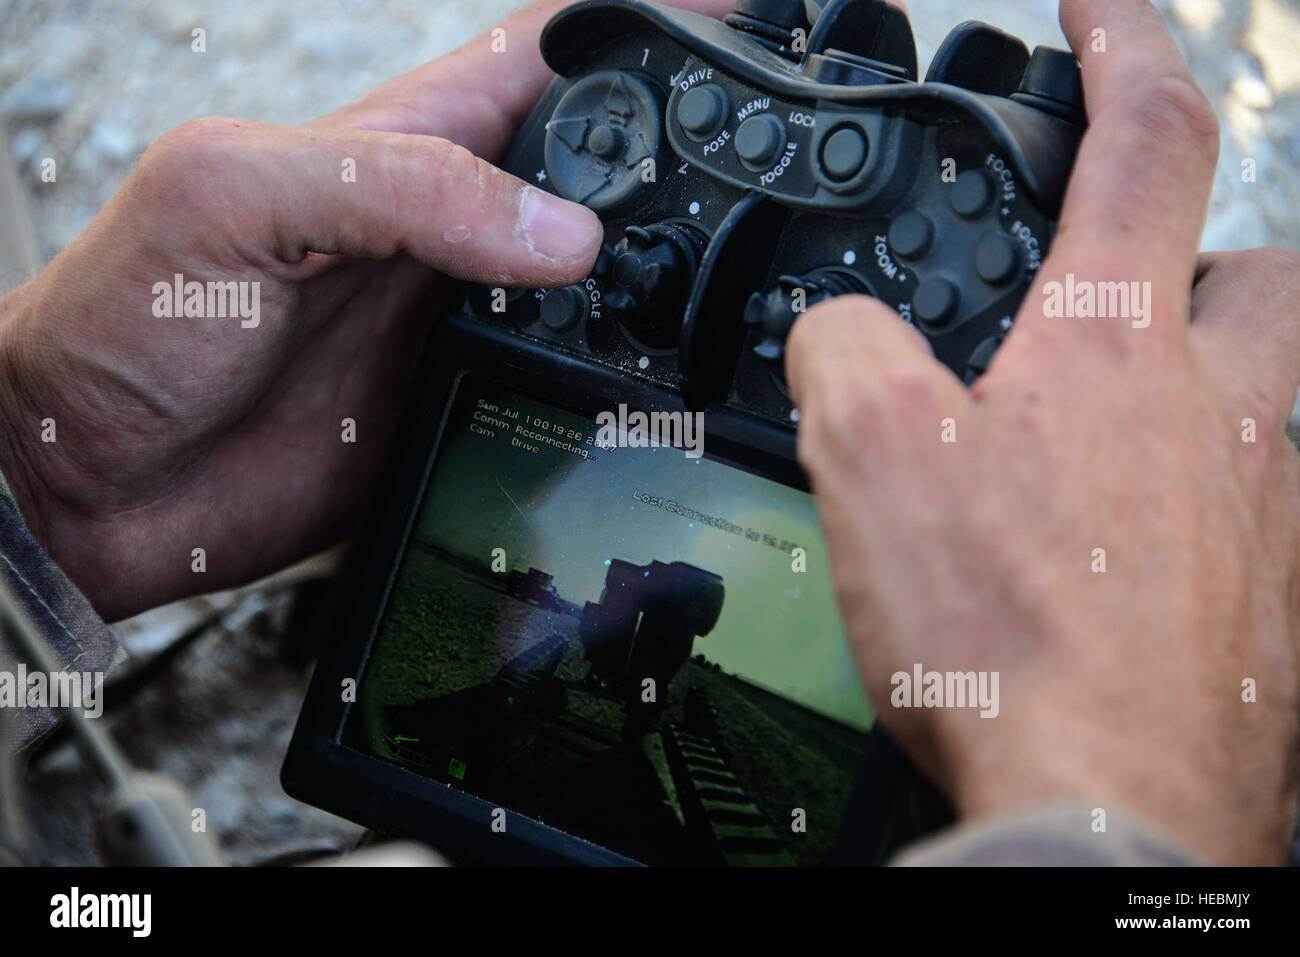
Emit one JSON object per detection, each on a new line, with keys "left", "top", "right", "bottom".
{"left": 889, "top": 804, "right": 1201, "bottom": 867}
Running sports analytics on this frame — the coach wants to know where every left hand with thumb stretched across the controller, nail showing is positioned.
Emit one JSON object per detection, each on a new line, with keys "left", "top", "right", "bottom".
{"left": 0, "top": 0, "right": 731, "bottom": 620}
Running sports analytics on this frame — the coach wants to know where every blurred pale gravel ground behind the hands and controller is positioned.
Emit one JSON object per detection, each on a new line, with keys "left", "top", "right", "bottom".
{"left": 0, "top": 0, "right": 1300, "bottom": 863}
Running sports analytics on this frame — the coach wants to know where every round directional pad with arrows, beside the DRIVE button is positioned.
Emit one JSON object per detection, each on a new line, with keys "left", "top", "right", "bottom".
{"left": 545, "top": 70, "right": 663, "bottom": 213}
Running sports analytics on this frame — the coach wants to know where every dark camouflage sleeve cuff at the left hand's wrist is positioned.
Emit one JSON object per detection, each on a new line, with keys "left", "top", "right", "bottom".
{"left": 0, "top": 475, "right": 126, "bottom": 748}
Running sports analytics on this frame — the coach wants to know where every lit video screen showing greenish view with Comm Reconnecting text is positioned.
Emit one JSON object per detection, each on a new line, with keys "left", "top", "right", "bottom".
{"left": 342, "top": 377, "right": 874, "bottom": 865}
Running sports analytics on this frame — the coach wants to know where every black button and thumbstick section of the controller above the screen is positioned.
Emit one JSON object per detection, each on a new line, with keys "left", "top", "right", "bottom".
{"left": 460, "top": 0, "right": 1086, "bottom": 429}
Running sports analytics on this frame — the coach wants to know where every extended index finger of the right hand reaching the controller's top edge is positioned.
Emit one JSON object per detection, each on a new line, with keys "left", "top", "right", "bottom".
{"left": 1008, "top": 0, "right": 1218, "bottom": 350}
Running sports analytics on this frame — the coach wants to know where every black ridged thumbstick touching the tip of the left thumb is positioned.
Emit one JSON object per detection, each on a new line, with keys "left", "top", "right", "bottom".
{"left": 597, "top": 222, "right": 709, "bottom": 348}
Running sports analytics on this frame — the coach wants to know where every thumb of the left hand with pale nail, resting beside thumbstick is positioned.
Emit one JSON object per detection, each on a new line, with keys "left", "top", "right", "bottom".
{"left": 135, "top": 118, "right": 602, "bottom": 286}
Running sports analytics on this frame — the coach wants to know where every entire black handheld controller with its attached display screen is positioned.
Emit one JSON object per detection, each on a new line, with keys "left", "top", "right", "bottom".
{"left": 283, "top": 0, "right": 1084, "bottom": 863}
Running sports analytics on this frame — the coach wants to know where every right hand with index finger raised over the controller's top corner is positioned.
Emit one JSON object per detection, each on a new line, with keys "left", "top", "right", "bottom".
{"left": 788, "top": 0, "right": 1300, "bottom": 863}
